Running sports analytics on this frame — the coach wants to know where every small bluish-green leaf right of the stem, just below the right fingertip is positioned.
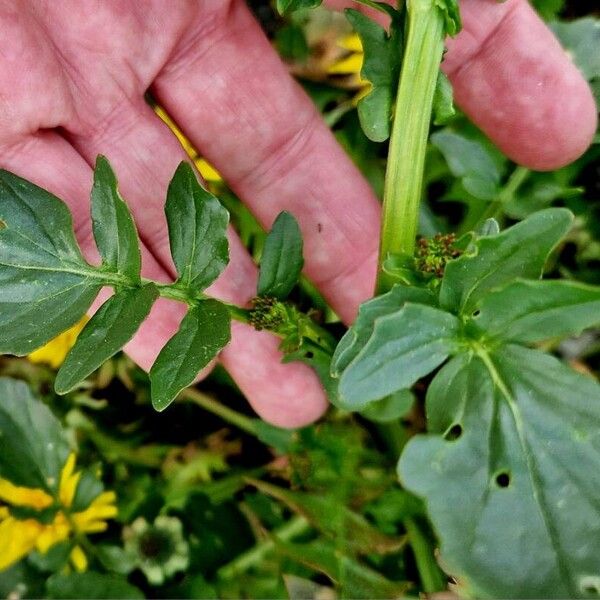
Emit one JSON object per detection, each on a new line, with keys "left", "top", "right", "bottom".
{"left": 431, "top": 129, "right": 501, "bottom": 200}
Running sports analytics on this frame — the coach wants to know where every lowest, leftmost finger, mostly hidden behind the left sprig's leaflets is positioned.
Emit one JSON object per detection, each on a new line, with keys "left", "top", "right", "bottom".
{"left": 0, "top": 130, "right": 184, "bottom": 376}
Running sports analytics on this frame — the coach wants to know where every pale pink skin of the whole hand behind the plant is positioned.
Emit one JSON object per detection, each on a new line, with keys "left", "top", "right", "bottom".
{"left": 0, "top": 0, "right": 596, "bottom": 427}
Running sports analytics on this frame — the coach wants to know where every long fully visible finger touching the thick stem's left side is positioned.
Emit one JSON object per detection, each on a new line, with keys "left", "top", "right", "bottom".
{"left": 153, "top": 1, "right": 379, "bottom": 328}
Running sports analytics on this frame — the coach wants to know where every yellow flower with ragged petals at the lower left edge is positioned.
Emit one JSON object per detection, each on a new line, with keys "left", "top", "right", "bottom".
{"left": 0, "top": 454, "right": 117, "bottom": 571}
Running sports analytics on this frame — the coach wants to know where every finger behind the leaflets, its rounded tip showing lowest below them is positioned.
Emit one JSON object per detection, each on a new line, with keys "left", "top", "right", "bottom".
{"left": 61, "top": 97, "right": 327, "bottom": 427}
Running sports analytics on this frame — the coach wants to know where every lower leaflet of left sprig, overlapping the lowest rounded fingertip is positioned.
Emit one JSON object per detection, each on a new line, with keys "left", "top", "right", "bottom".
{"left": 150, "top": 299, "right": 231, "bottom": 410}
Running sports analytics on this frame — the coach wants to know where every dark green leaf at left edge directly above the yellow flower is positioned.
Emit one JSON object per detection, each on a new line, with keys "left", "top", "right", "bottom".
{"left": 0, "top": 377, "right": 69, "bottom": 495}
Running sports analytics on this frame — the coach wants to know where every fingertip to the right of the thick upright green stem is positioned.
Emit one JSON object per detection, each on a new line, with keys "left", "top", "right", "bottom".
{"left": 329, "top": 0, "right": 597, "bottom": 170}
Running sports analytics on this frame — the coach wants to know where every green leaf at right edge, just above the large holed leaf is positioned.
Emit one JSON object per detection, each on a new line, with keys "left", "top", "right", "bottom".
{"left": 470, "top": 280, "right": 600, "bottom": 344}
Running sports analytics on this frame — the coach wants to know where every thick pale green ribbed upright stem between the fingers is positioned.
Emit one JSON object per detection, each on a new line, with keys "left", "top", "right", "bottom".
{"left": 376, "top": 0, "right": 444, "bottom": 294}
